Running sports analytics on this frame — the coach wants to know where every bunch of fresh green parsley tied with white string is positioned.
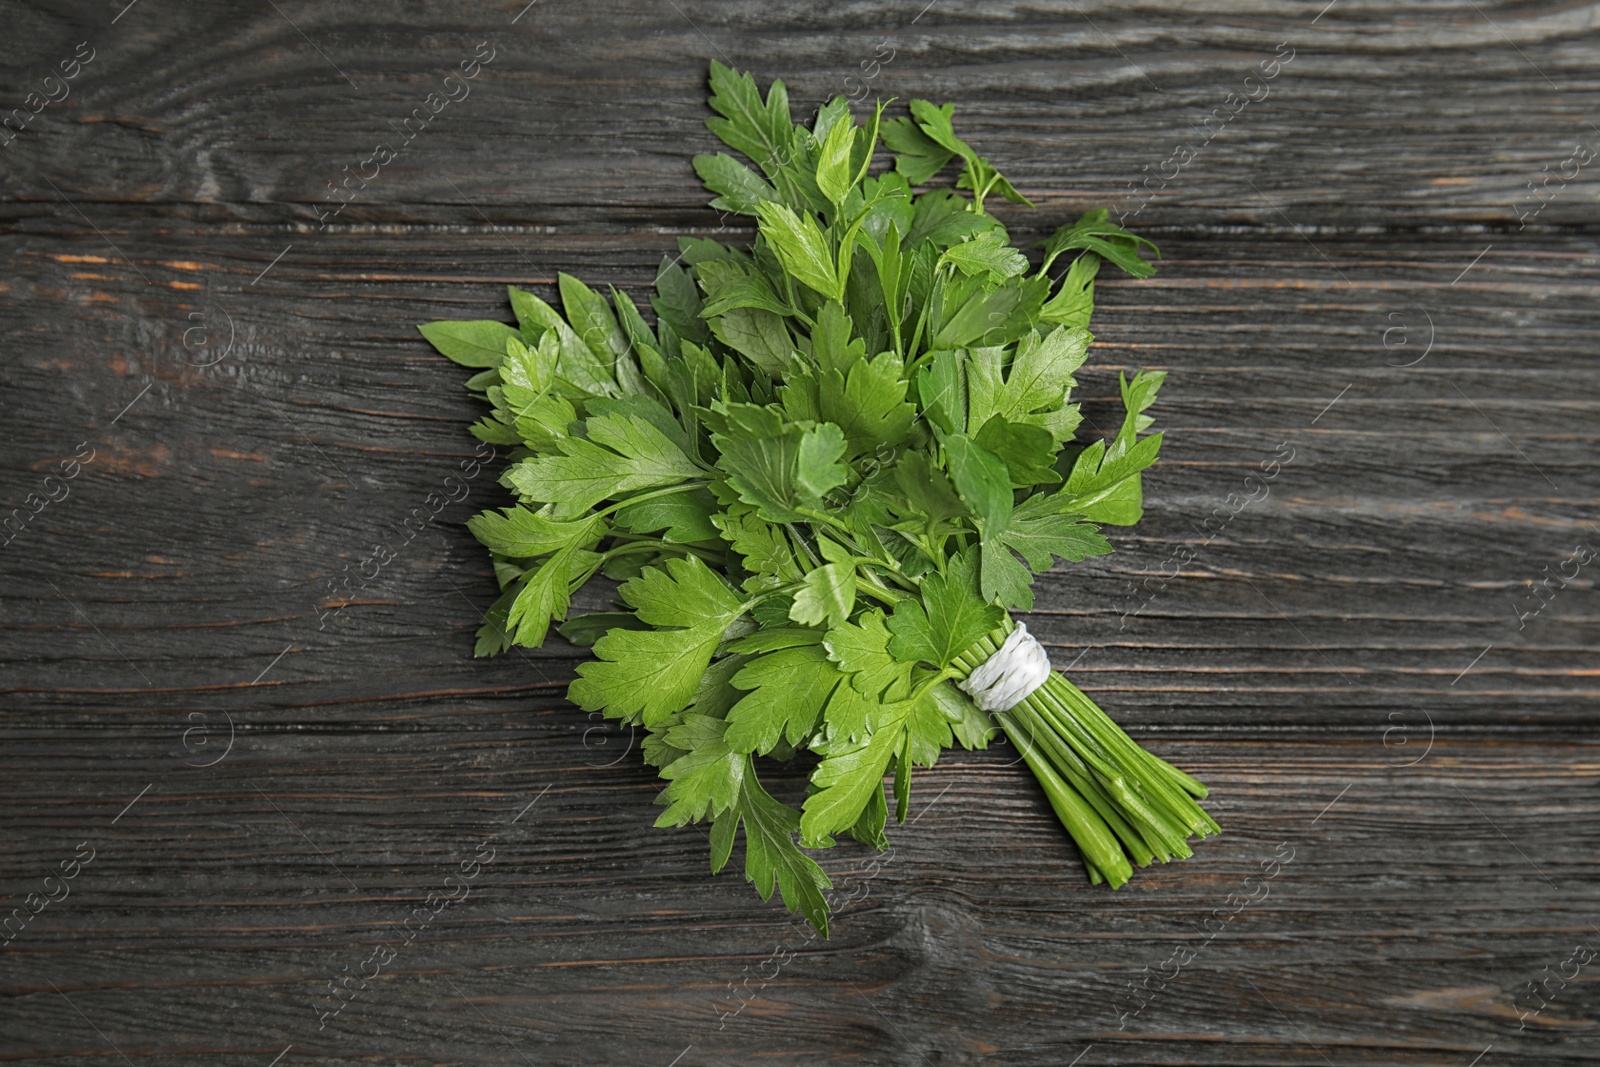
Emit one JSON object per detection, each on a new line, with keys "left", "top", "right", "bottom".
{"left": 421, "top": 64, "right": 1218, "bottom": 934}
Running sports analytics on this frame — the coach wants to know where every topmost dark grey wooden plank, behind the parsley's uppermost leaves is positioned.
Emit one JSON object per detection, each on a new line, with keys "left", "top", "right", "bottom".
{"left": 0, "top": 0, "right": 1600, "bottom": 230}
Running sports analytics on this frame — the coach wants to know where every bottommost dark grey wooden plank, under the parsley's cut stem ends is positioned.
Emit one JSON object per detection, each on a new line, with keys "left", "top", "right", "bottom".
{"left": 3, "top": 735, "right": 1600, "bottom": 1064}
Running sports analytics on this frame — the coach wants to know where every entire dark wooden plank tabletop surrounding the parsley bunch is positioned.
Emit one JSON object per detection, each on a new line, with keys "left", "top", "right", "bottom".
{"left": 0, "top": 0, "right": 1600, "bottom": 1067}
